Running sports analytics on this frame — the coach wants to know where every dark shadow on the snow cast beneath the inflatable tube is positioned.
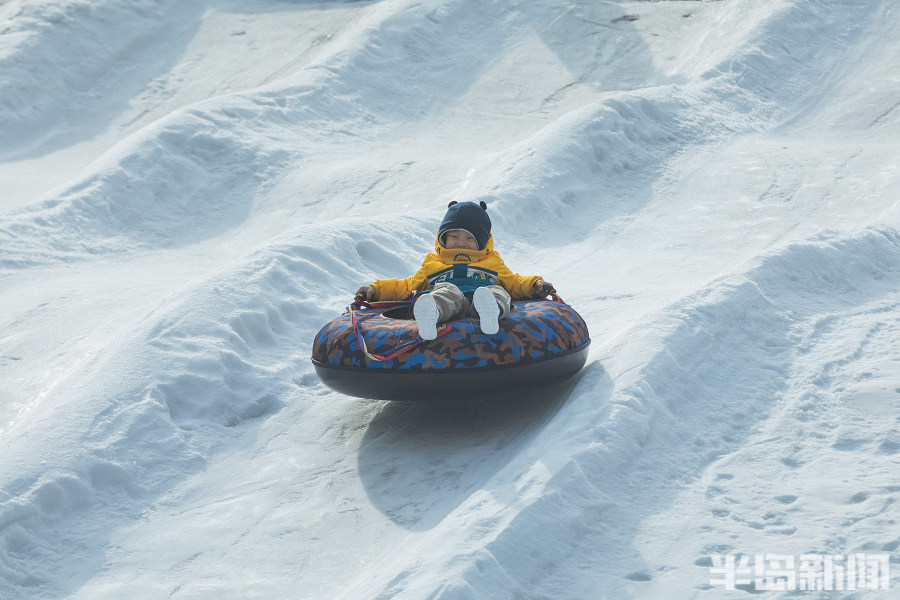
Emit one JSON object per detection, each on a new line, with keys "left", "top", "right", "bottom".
{"left": 357, "top": 363, "right": 609, "bottom": 531}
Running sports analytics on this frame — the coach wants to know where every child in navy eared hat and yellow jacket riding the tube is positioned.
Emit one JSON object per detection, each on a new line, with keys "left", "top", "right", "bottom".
{"left": 357, "top": 201, "right": 553, "bottom": 340}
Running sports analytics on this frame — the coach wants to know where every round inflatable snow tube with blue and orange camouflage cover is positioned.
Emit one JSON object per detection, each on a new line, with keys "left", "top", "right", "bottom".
{"left": 312, "top": 300, "right": 591, "bottom": 400}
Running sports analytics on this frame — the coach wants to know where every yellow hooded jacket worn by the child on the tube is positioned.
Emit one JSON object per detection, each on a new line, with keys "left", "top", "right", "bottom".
{"left": 372, "top": 236, "right": 541, "bottom": 300}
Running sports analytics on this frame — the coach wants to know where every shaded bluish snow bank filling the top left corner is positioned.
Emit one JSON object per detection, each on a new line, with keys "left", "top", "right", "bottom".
{"left": 0, "top": 0, "right": 198, "bottom": 159}
